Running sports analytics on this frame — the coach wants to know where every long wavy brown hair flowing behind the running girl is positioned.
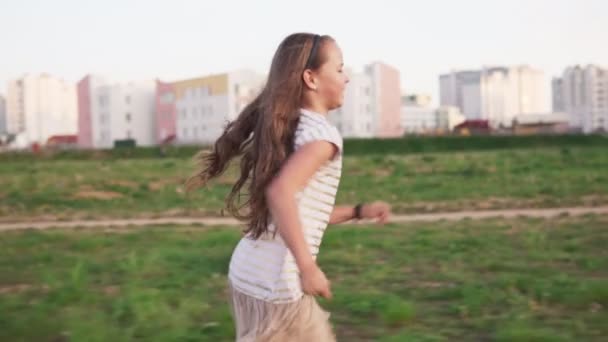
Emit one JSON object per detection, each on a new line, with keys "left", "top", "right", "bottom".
{"left": 187, "top": 33, "right": 333, "bottom": 239}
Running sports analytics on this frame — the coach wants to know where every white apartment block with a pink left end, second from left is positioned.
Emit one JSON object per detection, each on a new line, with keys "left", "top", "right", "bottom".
{"left": 78, "top": 75, "right": 157, "bottom": 148}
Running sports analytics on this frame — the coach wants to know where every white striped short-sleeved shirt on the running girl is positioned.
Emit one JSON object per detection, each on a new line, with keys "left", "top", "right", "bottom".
{"left": 228, "top": 109, "right": 342, "bottom": 304}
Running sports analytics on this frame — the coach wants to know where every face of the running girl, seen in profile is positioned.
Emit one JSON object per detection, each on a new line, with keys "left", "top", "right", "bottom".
{"left": 315, "top": 41, "right": 349, "bottom": 110}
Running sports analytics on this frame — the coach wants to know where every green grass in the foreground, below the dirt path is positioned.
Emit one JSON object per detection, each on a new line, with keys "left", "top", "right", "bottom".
{"left": 0, "top": 215, "right": 608, "bottom": 341}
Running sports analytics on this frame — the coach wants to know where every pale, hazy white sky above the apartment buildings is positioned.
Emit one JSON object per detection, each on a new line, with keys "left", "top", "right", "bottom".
{"left": 0, "top": 0, "right": 608, "bottom": 102}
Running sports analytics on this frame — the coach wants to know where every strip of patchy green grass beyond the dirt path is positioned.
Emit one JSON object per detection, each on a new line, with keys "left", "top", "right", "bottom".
{"left": 0, "top": 146, "right": 608, "bottom": 220}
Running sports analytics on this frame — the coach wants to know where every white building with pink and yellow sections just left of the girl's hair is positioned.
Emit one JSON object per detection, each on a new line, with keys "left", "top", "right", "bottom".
{"left": 156, "top": 70, "right": 265, "bottom": 144}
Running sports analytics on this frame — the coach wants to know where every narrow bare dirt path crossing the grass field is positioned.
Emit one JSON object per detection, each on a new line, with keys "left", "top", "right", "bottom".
{"left": 0, "top": 206, "right": 608, "bottom": 232}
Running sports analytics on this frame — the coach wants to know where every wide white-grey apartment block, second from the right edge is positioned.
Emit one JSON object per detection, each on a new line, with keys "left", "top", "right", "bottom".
{"left": 439, "top": 66, "right": 548, "bottom": 127}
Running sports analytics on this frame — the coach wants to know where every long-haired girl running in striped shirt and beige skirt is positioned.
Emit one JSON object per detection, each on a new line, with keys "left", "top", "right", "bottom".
{"left": 189, "top": 33, "right": 390, "bottom": 342}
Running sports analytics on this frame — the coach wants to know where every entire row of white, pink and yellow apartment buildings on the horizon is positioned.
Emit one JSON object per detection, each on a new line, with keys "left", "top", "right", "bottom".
{"left": 0, "top": 62, "right": 608, "bottom": 148}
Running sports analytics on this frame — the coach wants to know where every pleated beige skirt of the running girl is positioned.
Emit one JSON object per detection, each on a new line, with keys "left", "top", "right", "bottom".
{"left": 229, "top": 287, "right": 336, "bottom": 342}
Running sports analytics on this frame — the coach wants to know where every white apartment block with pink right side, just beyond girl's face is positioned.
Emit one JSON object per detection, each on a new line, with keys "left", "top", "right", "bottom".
{"left": 329, "top": 62, "right": 402, "bottom": 138}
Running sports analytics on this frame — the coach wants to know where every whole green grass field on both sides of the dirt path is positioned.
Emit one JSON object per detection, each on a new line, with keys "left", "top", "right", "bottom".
{"left": 0, "top": 136, "right": 608, "bottom": 342}
